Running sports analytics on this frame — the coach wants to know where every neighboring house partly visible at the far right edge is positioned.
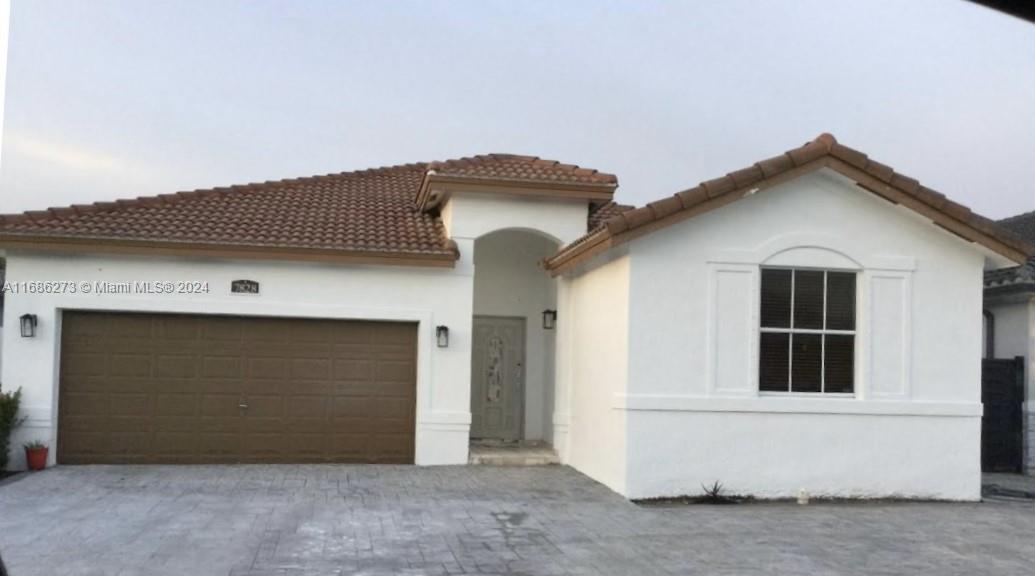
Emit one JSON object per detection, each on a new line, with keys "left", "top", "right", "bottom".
{"left": 984, "top": 207, "right": 1035, "bottom": 474}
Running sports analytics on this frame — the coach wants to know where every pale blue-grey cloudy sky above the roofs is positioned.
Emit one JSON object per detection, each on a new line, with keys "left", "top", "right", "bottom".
{"left": 0, "top": 0, "right": 1035, "bottom": 218}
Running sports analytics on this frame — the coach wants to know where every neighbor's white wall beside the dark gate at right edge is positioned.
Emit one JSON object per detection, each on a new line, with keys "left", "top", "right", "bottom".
{"left": 985, "top": 295, "right": 1035, "bottom": 474}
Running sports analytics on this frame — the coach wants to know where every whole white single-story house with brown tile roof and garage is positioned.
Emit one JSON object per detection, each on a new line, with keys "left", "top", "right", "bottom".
{"left": 0, "top": 134, "right": 1033, "bottom": 499}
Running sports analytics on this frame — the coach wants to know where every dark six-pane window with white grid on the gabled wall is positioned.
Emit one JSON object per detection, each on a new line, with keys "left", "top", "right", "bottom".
{"left": 759, "top": 268, "right": 855, "bottom": 394}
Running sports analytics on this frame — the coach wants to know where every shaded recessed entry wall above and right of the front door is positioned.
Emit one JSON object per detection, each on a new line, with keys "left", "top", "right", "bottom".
{"left": 474, "top": 231, "right": 557, "bottom": 441}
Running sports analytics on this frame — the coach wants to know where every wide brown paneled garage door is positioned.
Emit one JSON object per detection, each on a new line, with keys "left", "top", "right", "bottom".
{"left": 58, "top": 311, "right": 417, "bottom": 464}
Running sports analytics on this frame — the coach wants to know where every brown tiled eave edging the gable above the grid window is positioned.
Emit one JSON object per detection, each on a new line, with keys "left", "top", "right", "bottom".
{"left": 546, "top": 133, "right": 1035, "bottom": 275}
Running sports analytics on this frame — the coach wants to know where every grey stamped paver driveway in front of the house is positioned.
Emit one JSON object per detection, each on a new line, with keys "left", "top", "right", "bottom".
{"left": 0, "top": 465, "right": 1035, "bottom": 576}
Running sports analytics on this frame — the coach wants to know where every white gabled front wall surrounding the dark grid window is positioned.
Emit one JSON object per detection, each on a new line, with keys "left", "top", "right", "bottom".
{"left": 613, "top": 171, "right": 984, "bottom": 499}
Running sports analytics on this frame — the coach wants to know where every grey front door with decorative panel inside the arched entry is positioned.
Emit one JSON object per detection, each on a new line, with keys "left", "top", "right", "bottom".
{"left": 471, "top": 316, "right": 525, "bottom": 441}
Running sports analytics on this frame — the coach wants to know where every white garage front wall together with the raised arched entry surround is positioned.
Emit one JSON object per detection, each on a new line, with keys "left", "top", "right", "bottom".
{"left": 0, "top": 186, "right": 588, "bottom": 469}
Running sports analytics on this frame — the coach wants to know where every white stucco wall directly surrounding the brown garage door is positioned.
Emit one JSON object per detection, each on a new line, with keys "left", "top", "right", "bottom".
{"left": 2, "top": 252, "right": 473, "bottom": 465}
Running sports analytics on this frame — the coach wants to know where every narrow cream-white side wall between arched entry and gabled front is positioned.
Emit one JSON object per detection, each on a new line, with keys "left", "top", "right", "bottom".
{"left": 554, "top": 257, "right": 629, "bottom": 494}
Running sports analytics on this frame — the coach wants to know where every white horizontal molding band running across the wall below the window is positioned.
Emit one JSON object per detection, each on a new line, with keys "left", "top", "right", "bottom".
{"left": 612, "top": 393, "right": 982, "bottom": 418}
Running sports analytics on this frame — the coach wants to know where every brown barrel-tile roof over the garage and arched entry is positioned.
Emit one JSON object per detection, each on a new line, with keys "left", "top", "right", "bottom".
{"left": 0, "top": 154, "right": 612, "bottom": 260}
